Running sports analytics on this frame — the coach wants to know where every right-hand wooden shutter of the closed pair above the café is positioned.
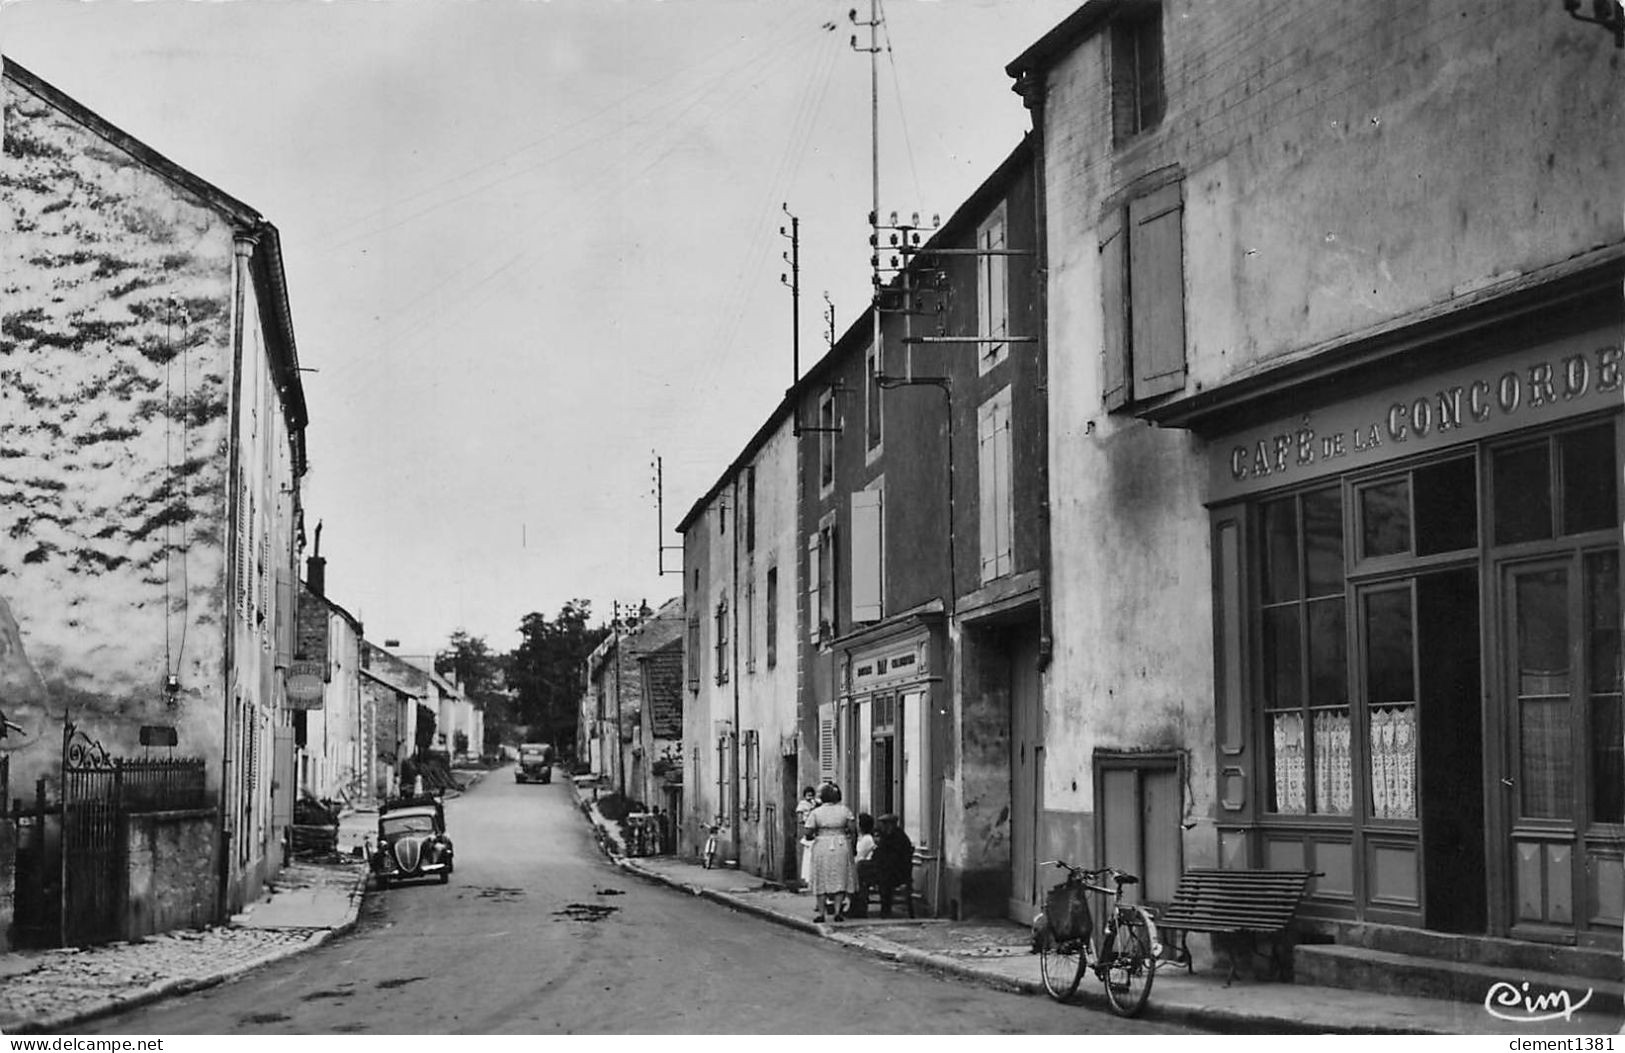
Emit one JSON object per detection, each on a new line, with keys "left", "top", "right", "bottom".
{"left": 1128, "top": 184, "right": 1185, "bottom": 398}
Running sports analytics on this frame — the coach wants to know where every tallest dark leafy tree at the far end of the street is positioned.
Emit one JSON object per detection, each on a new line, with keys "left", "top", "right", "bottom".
{"left": 509, "top": 600, "right": 609, "bottom": 749}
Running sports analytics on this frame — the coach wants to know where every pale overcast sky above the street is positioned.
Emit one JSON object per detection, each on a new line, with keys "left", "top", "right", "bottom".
{"left": 0, "top": 0, "right": 1079, "bottom": 653}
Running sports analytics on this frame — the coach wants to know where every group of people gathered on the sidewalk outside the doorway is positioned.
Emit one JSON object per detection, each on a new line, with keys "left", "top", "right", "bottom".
{"left": 796, "top": 783, "right": 913, "bottom": 921}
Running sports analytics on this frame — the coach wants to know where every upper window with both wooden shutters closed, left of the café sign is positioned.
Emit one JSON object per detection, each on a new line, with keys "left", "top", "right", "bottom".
{"left": 1100, "top": 182, "right": 1185, "bottom": 410}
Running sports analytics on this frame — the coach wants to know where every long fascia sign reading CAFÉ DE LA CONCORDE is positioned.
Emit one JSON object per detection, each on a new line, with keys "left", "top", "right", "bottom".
{"left": 1211, "top": 335, "right": 1625, "bottom": 501}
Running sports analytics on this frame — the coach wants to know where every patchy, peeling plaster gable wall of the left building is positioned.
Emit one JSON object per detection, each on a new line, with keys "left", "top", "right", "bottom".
{"left": 0, "top": 78, "right": 237, "bottom": 802}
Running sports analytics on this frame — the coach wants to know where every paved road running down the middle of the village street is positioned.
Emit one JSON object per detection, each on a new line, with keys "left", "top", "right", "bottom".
{"left": 85, "top": 772, "right": 1209, "bottom": 1035}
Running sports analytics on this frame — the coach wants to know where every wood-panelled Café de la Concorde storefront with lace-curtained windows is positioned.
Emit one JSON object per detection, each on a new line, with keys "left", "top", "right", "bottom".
{"left": 1193, "top": 294, "right": 1625, "bottom": 947}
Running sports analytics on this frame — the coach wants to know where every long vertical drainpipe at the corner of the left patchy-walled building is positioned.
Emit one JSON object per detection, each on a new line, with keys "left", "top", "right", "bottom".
{"left": 216, "top": 232, "right": 258, "bottom": 921}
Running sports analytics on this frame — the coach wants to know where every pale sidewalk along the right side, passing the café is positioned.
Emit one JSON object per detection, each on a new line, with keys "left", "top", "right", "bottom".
{"left": 572, "top": 780, "right": 1620, "bottom": 1035}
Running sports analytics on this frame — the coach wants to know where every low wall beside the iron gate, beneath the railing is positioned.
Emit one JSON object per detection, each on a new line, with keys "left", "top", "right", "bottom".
{"left": 122, "top": 809, "right": 218, "bottom": 939}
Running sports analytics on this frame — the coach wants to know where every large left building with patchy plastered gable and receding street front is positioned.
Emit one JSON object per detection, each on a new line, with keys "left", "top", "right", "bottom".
{"left": 0, "top": 62, "right": 306, "bottom": 915}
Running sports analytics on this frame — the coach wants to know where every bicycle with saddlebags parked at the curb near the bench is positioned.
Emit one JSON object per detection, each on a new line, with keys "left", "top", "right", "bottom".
{"left": 1032, "top": 860, "right": 1162, "bottom": 1017}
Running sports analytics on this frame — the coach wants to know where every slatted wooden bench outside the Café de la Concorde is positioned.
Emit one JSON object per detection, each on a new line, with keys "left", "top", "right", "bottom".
{"left": 1157, "top": 868, "right": 1321, "bottom": 986}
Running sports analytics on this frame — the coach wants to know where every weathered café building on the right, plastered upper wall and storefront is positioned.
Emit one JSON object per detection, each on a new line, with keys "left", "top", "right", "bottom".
{"left": 1009, "top": 0, "right": 1625, "bottom": 947}
